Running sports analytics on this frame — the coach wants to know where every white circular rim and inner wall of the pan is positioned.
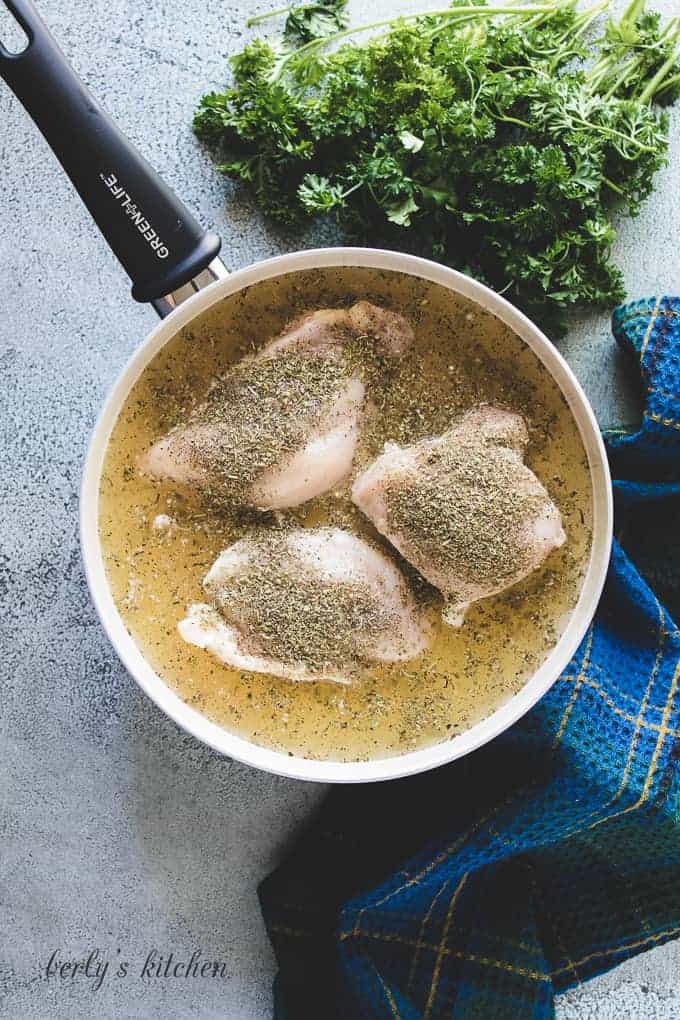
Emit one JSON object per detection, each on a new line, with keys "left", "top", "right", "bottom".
{"left": 81, "top": 248, "right": 613, "bottom": 782}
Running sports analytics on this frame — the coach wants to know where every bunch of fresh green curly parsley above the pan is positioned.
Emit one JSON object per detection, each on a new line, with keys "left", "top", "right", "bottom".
{"left": 195, "top": 0, "right": 680, "bottom": 334}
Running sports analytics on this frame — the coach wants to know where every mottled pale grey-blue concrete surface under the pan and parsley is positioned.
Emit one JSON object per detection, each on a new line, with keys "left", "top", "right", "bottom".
{"left": 0, "top": 0, "right": 680, "bottom": 1020}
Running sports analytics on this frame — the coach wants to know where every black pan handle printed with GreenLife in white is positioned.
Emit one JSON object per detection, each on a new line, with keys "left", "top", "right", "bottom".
{"left": 0, "top": 0, "right": 220, "bottom": 301}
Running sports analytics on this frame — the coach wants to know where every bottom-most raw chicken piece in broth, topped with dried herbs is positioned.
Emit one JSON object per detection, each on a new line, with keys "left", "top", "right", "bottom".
{"left": 178, "top": 527, "right": 428, "bottom": 683}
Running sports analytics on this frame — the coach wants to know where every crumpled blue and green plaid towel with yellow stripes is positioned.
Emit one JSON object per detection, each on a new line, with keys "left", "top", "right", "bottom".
{"left": 260, "top": 297, "right": 680, "bottom": 1020}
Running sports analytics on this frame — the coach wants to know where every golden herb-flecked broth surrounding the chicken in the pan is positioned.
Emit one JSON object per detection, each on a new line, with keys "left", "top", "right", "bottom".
{"left": 99, "top": 268, "right": 591, "bottom": 761}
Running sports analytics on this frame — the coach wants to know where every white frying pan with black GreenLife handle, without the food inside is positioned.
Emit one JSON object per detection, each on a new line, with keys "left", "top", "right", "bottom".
{"left": 0, "top": 0, "right": 613, "bottom": 782}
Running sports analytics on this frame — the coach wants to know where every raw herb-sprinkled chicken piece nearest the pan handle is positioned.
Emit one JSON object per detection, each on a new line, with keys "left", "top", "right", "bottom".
{"left": 139, "top": 301, "right": 413, "bottom": 510}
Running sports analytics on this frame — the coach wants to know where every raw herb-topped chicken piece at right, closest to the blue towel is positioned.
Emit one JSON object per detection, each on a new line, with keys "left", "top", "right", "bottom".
{"left": 352, "top": 406, "right": 566, "bottom": 626}
